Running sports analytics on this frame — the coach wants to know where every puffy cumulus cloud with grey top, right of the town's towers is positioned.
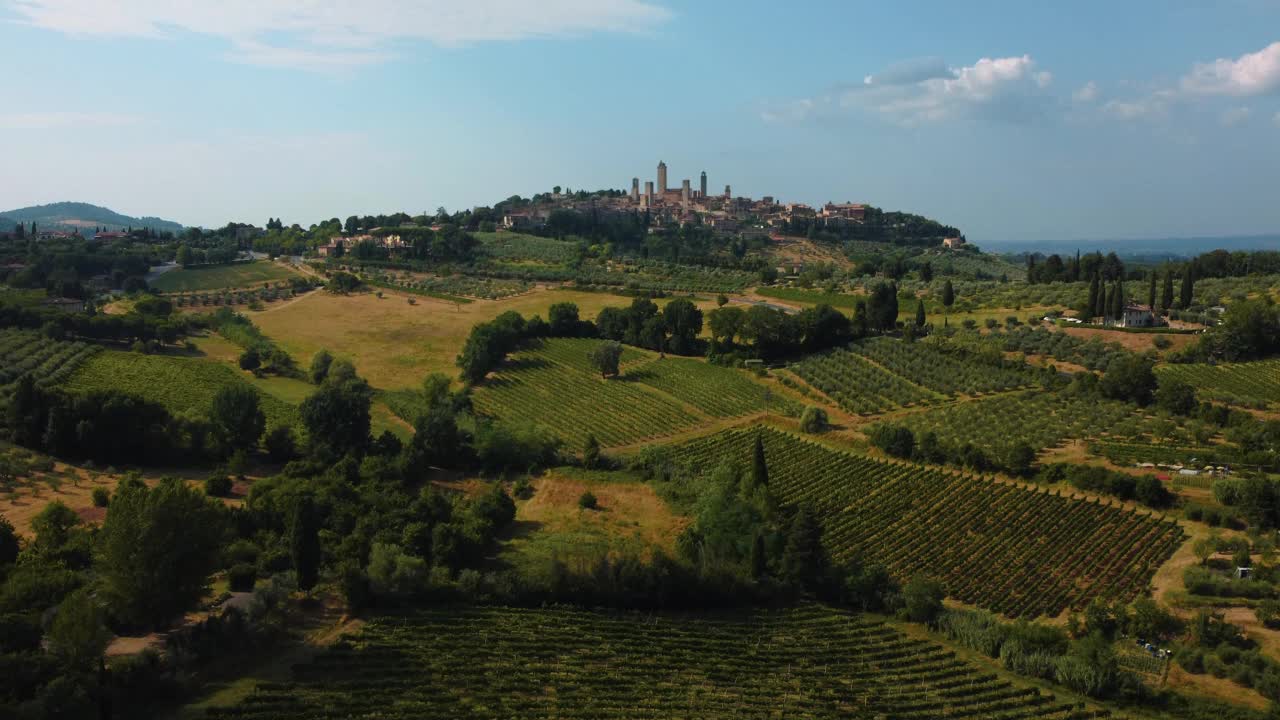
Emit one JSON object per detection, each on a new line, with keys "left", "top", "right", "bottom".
{"left": 762, "top": 55, "right": 1053, "bottom": 126}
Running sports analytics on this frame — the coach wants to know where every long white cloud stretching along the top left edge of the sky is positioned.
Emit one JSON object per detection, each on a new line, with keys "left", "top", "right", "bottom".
{"left": 0, "top": 0, "right": 671, "bottom": 69}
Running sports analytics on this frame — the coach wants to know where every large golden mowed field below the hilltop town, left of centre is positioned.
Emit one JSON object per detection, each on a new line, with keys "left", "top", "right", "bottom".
{"left": 253, "top": 284, "right": 716, "bottom": 389}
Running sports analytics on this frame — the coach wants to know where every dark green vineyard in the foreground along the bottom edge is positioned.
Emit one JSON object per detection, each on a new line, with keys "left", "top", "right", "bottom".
{"left": 207, "top": 606, "right": 1106, "bottom": 720}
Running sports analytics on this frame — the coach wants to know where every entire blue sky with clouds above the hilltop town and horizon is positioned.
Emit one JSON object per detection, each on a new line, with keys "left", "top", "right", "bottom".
{"left": 0, "top": 0, "right": 1280, "bottom": 243}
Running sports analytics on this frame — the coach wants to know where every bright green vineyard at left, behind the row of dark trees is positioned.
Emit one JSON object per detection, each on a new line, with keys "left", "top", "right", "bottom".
{"left": 64, "top": 350, "right": 298, "bottom": 428}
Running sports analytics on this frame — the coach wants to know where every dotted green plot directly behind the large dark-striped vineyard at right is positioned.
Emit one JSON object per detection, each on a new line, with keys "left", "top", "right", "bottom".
{"left": 870, "top": 391, "right": 1151, "bottom": 455}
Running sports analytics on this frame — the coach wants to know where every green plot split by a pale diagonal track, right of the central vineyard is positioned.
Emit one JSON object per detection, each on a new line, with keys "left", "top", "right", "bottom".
{"left": 790, "top": 338, "right": 1036, "bottom": 414}
